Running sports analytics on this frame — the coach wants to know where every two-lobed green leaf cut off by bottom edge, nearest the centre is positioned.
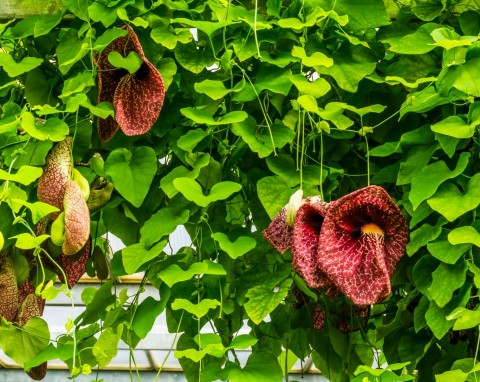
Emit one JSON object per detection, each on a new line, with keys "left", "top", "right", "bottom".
{"left": 221, "top": 350, "right": 282, "bottom": 382}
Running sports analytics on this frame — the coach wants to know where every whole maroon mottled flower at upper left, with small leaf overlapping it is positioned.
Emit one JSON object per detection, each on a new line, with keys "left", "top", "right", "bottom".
{"left": 95, "top": 26, "right": 165, "bottom": 141}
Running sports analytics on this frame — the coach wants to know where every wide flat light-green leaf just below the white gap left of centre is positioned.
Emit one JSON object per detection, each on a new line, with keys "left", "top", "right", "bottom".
{"left": 158, "top": 260, "right": 227, "bottom": 287}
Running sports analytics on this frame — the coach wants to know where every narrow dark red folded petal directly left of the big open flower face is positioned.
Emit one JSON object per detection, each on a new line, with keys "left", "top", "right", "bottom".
{"left": 292, "top": 197, "right": 332, "bottom": 289}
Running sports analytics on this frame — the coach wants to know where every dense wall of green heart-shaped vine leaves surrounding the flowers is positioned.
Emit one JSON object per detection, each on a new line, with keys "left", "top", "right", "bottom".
{"left": 0, "top": 0, "right": 480, "bottom": 382}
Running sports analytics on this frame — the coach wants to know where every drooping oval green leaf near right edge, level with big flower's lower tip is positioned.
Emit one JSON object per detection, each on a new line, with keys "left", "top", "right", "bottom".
{"left": 429, "top": 260, "right": 467, "bottom": 308}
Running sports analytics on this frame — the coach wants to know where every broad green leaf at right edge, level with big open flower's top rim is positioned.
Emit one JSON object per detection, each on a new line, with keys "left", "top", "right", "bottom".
{"left": 427, "top": 174, "right": 480, "bottom": 222}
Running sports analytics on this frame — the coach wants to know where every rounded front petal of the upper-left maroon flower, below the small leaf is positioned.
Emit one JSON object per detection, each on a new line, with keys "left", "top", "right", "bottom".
{"left": 113, "top": 61, "right": 165, "bottom": 135}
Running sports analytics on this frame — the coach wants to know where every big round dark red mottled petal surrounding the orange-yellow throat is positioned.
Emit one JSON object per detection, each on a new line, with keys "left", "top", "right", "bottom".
{"left": 317, "top": 186, "right": 408, "bottom": 305}
